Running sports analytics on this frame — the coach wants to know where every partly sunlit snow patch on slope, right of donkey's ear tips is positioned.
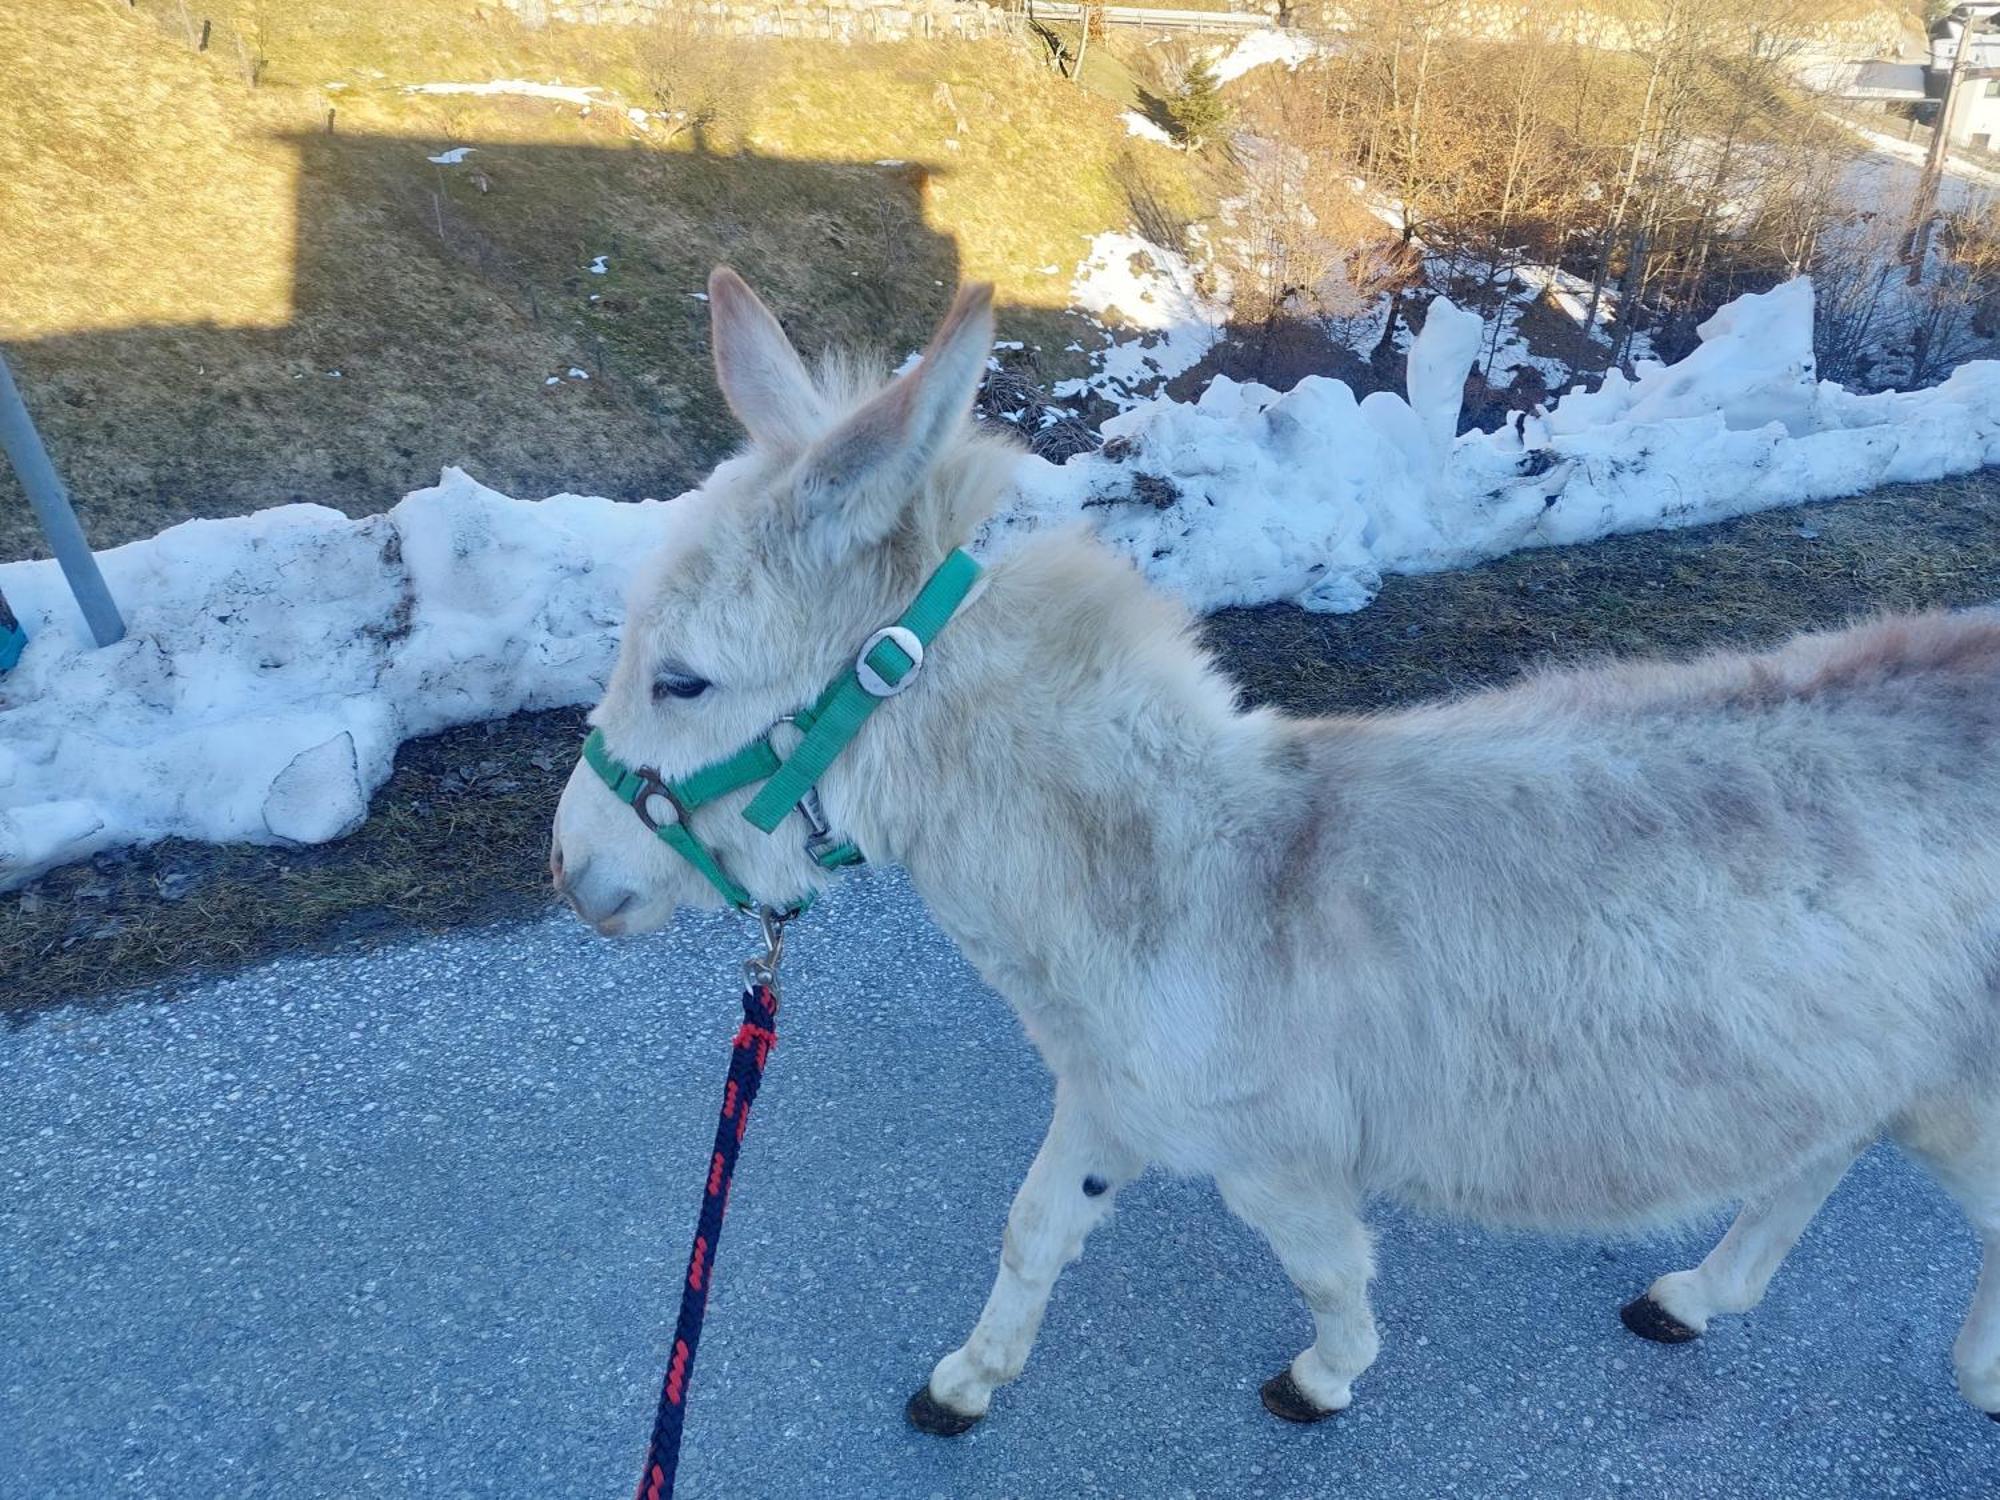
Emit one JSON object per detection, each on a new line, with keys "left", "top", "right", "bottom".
{"left": 1054, "top": 230, "right": 1230, "bottom": 408}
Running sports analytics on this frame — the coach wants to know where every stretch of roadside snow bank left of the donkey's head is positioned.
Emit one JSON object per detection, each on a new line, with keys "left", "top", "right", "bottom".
{"left": 0, "top": 468, "right": 666, "bottom": 888}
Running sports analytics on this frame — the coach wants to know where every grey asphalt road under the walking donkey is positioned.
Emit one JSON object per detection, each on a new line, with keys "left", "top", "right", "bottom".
{"left": 0, "top": 876, "right": 2000, "bottom": 1500}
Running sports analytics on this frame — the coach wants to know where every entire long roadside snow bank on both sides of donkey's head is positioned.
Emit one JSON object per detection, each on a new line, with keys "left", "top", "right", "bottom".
{"left": 0, "top": 282, "right": 2000, "bottom": 888}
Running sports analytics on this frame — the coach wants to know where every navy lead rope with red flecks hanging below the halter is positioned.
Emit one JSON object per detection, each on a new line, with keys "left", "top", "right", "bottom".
{"left": 638, "top": 984, "right": 778, "bottom": 1500}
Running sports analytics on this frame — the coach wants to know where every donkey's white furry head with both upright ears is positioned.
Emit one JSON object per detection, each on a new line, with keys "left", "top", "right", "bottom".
{"left": 550, "top": 270, "right": 1014, "bottom": 934}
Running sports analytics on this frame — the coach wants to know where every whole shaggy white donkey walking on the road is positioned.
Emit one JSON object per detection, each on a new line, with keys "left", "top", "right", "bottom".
{"left": 552, "top": 270, "right": 2000, "bottom": 1432}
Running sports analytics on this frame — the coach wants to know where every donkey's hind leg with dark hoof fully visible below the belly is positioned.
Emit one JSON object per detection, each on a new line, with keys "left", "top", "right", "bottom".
{"left": 1618, "top": 1146, "right": 1860, "bottom": 1344}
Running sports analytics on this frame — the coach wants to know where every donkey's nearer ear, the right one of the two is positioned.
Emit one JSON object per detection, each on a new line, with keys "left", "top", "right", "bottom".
{"left": 796, "top": 282, "right": 994, "bottom": 554}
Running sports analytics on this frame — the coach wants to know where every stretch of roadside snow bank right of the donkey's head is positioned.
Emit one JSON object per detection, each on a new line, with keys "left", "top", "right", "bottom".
{"left": 988, "top": 280, "right": 2000, "bottom": 610}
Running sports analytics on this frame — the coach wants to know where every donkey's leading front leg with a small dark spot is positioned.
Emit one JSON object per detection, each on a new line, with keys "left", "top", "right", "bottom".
{"left": 906, "top": 1082, "right": 1146, "bottom": 1438}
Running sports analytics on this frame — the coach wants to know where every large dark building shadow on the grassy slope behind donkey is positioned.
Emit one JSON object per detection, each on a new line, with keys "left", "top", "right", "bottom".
{"left": 0, "top": 132, "right": 968, "bottom": 558}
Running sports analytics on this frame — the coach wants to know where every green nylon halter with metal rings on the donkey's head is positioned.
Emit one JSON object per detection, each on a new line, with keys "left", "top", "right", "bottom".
{"left": 584, "top": 550, "right": 984, "bottom": 916}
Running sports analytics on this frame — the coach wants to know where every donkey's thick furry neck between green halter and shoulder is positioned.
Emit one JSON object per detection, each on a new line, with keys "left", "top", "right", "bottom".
{"left": 826, "top": 536, "right": 1300, "bottom": 1040}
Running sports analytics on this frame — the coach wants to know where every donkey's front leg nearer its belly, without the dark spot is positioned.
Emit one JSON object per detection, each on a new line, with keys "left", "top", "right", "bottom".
{"left": 1216, "top": 1176, "right": 1382, "bottom": 1422}
